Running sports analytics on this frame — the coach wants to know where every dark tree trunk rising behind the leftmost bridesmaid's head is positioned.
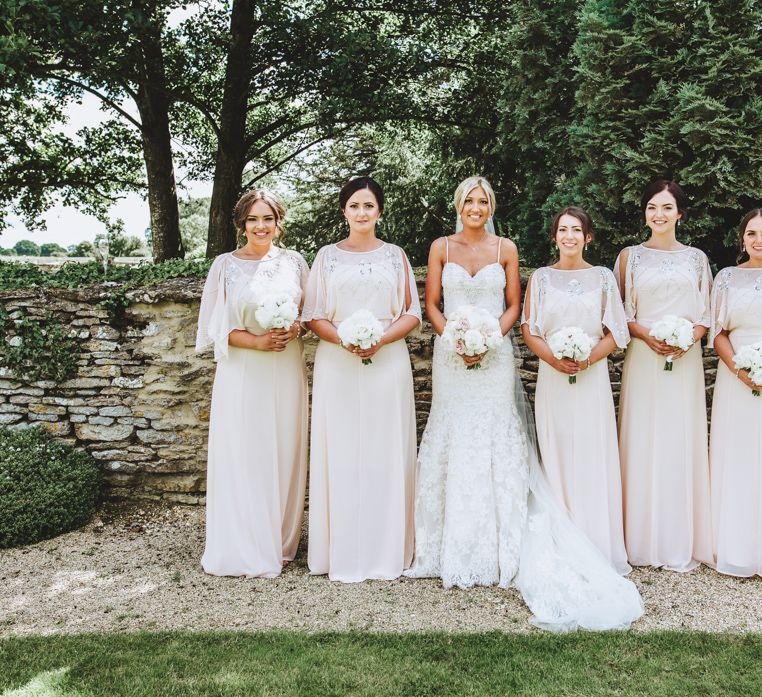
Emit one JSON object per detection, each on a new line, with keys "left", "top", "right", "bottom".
{"left": 206, "top": 0, "right": 255, "bottom": 258}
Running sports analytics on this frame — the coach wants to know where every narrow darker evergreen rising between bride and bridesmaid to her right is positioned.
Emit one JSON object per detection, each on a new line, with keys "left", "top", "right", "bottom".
{"left": 493, "top": 0, "right": 581, "bottom": 266}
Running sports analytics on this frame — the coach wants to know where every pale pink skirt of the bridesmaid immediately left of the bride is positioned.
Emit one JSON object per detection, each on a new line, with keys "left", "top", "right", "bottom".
{"left": 308, "top": 341, "right": 416, "bottom": 583}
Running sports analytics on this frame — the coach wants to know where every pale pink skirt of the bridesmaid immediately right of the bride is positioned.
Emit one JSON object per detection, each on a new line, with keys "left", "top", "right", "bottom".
{"left": 535, "top": 361, "right": 631, "bottom": 574}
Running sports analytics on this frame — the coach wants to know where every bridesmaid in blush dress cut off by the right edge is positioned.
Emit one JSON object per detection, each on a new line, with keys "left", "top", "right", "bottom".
{"left": 709, "top": 208, "right": 762, "bottom": 576}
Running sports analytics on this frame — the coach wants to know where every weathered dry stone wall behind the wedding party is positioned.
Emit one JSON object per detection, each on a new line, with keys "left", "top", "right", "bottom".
{"left": 0, "top": 279, "right": 716, "bottom": 503}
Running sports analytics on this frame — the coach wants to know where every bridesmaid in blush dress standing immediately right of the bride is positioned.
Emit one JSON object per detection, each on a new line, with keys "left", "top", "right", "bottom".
{"left": 521, "top": 206, "right": 631, "bottom": 574}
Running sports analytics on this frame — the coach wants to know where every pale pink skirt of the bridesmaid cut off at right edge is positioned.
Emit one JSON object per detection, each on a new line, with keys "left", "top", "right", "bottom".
{"left": 710, "top": 361, "right": 762, "bottom": 576}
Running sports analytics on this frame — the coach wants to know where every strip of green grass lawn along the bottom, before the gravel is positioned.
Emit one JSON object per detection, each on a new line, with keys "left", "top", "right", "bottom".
{"left": 0, "top": 632, "right": 762, "bottom": 697}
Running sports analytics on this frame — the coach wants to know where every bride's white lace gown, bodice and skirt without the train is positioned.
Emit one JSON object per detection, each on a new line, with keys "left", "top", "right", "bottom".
{"left": 407, "top": 263, "right": 528, "bottom": 588}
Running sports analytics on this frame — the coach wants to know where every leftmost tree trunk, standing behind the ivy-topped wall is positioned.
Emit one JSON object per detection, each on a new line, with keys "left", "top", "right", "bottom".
{"left": 135, "top": 27, "right": 185, "bottom": 262}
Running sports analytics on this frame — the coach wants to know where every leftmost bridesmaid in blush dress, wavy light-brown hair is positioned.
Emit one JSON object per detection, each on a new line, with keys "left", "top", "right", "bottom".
{"left": 196, "top": 189, "right": 309, "bottom": 578}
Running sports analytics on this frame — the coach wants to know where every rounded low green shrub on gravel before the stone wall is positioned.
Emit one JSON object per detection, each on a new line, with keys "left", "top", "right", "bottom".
{"left": 0, "top": 427, "right": 101, "bottom": 548}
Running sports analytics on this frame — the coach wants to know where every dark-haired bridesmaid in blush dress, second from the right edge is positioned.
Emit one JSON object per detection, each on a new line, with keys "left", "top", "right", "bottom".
{"left": 614, "top": 179, "right": 712, "bottom": 571}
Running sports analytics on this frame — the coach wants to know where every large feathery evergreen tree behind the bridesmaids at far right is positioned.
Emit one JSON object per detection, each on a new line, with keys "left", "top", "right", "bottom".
{"left": 568, "top": 0, "right": 762, "bottom": 265}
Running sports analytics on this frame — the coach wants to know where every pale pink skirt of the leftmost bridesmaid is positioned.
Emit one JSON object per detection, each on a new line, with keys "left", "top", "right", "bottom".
{"left": 201, "top": 339, "right": 308, "bottom": 578}
